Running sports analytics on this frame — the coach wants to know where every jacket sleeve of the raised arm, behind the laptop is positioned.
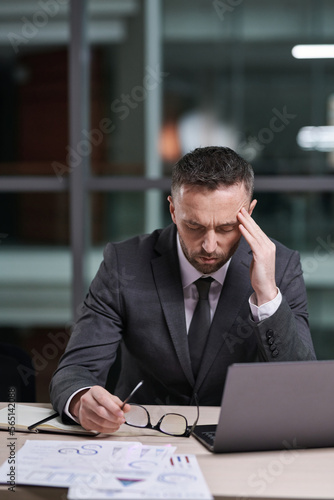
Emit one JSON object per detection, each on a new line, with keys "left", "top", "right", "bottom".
{"left": 253, "top": 252, "right": 316, "bottom": 361}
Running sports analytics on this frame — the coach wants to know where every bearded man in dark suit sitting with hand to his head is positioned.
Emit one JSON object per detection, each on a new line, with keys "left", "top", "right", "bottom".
{"left": 51, "top": 147, "right": 315, "bottom": 432}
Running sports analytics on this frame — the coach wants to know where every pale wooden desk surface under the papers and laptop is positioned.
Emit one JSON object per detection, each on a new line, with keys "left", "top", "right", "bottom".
{"left": 0, "top": 403, "right": 334, "bottom": 500}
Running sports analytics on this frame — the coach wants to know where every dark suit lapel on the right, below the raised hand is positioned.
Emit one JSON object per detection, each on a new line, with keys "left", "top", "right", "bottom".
{"left": 195, "top": 238, "right": 252, "bottom": 390}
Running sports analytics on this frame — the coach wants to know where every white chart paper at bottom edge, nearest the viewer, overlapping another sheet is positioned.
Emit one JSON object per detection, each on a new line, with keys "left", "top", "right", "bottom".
{"left": 67, "top": 455, "right": 213, "bottom": 500}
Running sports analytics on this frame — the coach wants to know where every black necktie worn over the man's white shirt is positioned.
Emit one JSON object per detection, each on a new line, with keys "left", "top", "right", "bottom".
{"left": 188, "top": 277, "right": 214, "bottom": 378}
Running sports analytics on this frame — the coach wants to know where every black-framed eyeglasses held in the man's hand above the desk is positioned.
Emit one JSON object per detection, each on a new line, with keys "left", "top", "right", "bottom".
{"left": 124, "top": 401, "right": 199, "bottom": 437}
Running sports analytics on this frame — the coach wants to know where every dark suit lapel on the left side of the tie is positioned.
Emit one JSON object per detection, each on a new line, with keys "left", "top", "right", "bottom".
{"left": 151, "top": 225, "right": 194, "bottom": 385}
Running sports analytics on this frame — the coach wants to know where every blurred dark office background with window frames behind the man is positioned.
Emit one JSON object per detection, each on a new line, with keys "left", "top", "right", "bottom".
{"left": 0, "top": 0, "right": 334, "bottom": 401}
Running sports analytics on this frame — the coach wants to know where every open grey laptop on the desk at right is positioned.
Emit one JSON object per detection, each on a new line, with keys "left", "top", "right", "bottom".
{"left": 193, "top": 361, "right": 334, "bottom": 453}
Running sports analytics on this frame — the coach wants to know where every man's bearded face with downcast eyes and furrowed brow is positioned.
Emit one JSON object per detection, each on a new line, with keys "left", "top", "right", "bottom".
{"left": 168, "top": 184, "right": 256, "bottom": 274}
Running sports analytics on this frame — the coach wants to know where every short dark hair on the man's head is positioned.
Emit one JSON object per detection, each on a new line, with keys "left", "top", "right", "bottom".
{"left": 172, "top": 146, "right": 254, "bottom": 197}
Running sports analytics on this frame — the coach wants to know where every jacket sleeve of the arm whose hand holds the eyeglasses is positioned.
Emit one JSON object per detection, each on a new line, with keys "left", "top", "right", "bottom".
{"left": 50, "top": 244, "right": 126, "bottom": 420}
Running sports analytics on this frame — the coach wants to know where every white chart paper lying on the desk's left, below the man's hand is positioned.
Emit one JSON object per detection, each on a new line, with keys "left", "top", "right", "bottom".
{"left": 0, "top": 439, "right": 175, "bottom": 490}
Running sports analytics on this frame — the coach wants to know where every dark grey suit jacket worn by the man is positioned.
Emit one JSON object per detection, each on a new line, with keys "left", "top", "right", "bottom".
{"left": 51, "top": 224, "right": 315, "bottom": 413}
